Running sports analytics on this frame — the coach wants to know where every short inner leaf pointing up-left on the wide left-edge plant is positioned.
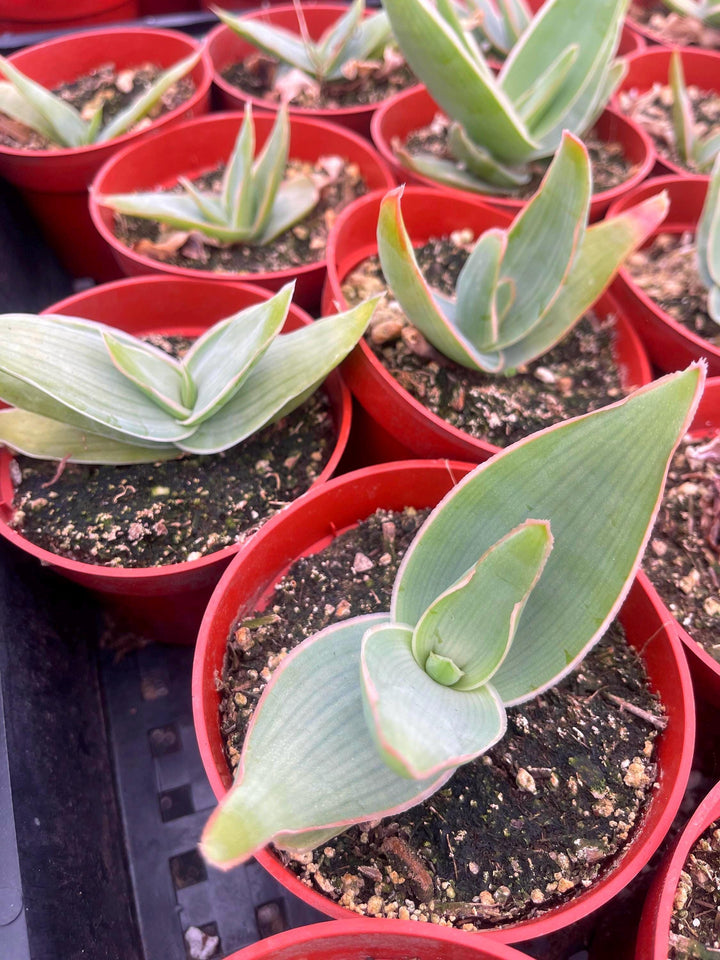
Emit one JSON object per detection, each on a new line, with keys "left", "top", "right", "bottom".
{"left": 103, "top": 333, "right": 190, "bottom": 419}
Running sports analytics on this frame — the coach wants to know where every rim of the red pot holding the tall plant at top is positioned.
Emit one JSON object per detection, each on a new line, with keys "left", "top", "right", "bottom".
{"left": 370, "top": 86, "right": 656, "bottom": 218}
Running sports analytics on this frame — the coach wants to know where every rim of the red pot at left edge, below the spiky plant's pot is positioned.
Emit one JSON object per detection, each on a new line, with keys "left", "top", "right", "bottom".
{"left": 0, "top": 276, "right": 351, "bottom": 585}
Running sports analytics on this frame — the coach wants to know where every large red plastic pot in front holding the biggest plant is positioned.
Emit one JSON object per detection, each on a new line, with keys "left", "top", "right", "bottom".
{"left": 192, "top": 461, "right": 695, "bottom": 943}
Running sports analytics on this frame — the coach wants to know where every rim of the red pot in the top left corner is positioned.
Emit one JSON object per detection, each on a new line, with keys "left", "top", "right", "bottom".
{"left": 0, "top": 26, "right": 212, "bottom": 160}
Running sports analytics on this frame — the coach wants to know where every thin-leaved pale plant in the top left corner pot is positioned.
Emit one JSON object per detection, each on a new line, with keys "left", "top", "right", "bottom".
{"left": 0, "top": 50, "right": 202, "bottom": 147}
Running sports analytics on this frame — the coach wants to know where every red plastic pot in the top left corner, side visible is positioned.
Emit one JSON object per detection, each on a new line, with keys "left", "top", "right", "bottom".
{"left": 0, "top": 27, "right": 212, "bottom": 280}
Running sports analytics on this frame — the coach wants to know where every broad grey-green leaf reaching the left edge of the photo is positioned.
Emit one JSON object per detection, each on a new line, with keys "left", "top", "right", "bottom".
{"left": 0, "top": 314, "right": 194, "bottom": 443}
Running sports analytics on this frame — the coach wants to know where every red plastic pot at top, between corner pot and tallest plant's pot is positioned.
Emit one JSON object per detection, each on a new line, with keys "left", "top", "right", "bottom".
{"left": 207, "top": 3, "right": 420, "bottom": 137}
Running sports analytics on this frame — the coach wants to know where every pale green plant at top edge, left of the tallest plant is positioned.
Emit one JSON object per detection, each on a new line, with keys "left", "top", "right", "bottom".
{"left": 210, "top": 0, "right": 393, "bottom": 82}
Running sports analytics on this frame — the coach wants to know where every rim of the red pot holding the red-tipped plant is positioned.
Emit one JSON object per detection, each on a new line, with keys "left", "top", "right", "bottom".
{"left": 323, "top": 187, "right": 653, "bottom": 459}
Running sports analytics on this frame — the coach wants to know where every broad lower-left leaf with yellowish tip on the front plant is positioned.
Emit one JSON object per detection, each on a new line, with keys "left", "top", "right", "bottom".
{"left": 201, "top": 614, "right": 449, "bottom": 868}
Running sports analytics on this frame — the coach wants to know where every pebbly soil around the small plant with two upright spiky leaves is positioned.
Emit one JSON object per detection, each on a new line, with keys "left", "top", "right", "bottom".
{"left": 115, "top": 156, "right": 366, "bottom": 273}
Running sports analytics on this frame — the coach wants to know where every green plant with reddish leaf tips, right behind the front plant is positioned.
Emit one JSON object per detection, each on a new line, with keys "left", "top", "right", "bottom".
{"left": 377, "top": 134, "right": 668, "bottom": 373}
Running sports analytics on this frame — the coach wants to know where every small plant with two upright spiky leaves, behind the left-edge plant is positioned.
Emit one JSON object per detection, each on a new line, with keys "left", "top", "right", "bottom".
{"left": 99, "top": 104, "right": 320, "bottom": 246}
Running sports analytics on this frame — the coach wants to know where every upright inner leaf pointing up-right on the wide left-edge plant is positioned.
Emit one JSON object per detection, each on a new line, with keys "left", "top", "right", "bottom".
{"left": 184, "top": 283, "right": 294, "bottom": 427}
